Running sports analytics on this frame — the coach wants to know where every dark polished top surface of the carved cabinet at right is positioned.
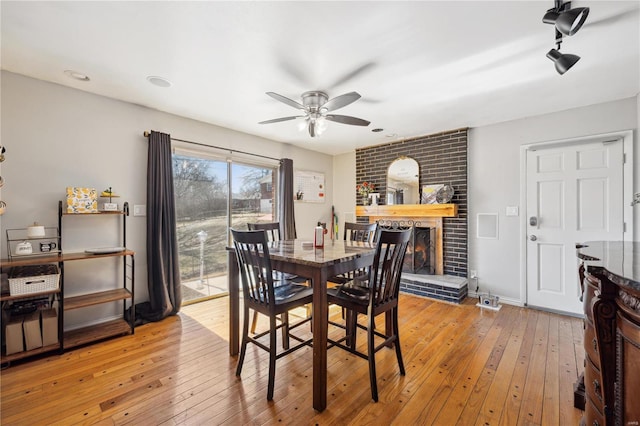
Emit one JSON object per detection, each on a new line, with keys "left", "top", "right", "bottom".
{"left": 576, "top": 241, "right": 640, "bottom": 291}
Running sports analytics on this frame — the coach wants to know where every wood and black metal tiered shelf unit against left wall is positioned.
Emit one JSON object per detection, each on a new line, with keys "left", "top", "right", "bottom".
{"left": 0, "top": 201, "right": 135, "bottom": 364}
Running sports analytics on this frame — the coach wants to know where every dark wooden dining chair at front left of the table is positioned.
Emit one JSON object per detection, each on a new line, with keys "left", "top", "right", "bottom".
{"left": 231, "top": 229, "right": 313, "bottom": 401}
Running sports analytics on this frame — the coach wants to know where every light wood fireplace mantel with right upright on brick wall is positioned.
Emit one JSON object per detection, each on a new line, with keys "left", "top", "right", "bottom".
{"left": 356, "top": 204, "right": 458, "bottom": 275}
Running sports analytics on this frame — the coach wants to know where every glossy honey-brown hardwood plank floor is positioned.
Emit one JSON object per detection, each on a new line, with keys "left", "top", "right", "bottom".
{"left": 0, "top": 295, "right": 584, "bottom": 425}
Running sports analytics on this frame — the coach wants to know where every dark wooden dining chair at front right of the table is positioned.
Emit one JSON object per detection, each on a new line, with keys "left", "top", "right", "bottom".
{"left": 327, "top": 229, "right": 411, "bottom": 402}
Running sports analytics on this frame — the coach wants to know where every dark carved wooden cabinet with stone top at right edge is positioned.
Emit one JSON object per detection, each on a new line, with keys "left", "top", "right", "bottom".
{"left": 577, "top": 242, "right": 640, "bottom": 425}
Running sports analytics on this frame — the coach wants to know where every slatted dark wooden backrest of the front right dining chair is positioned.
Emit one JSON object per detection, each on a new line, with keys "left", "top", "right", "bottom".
{"left": 369, "top": 229, "right": 411, "bottom": 308}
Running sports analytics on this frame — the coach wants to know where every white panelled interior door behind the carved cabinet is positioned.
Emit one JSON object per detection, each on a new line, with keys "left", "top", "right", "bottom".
{"left": 527, "top": 139, "right": 623, "bottom": 314}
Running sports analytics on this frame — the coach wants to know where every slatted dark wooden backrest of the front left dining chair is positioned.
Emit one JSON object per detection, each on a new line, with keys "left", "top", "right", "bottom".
{"left": 231, "top": 229, "right": 275, "bottom": 308}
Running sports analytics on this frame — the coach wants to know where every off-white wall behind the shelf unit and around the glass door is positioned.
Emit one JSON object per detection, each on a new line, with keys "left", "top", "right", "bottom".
{"left": 0, "top": 71, "right": 333, "bottom": 326}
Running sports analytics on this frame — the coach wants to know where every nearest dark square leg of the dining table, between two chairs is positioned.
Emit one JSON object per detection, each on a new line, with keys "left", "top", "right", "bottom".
{"left": 312, "top": 269, "right": 329, "bottom": 411}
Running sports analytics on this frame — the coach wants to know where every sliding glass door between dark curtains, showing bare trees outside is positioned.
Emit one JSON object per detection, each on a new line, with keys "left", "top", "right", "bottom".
{"left": 173, "top": 151, "right": 277, "bottom": 304}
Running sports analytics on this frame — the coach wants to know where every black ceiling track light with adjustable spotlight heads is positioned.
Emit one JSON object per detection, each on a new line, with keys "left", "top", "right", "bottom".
{"left": 542, "top": 0, "right": 589, "bottom": 75}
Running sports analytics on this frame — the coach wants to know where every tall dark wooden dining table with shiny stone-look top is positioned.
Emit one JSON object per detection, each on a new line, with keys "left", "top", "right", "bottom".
{"left": 227, "top": 239, "right": 376, "bottom": 411}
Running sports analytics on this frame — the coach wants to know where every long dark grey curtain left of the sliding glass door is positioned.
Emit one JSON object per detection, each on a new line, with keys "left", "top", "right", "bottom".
{"left": 140, "top": 131, "right": 182, "bottom": 321}
